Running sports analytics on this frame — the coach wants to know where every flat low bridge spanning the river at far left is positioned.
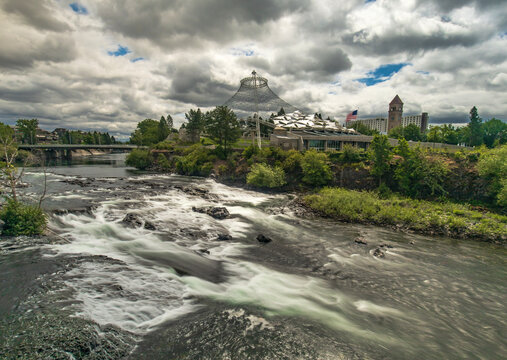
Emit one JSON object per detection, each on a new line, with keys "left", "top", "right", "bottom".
{"left": 18, "top": 144, "right": 148, "bottom": 160}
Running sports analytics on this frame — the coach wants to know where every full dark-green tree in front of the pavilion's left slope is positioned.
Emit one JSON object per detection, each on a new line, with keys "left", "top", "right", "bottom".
{"left": 206, "top": 106, "right": 241, "bottom": 155}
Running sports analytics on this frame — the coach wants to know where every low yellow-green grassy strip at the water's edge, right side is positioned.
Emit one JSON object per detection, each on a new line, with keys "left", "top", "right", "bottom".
{"left": 304, "top": 188, "right": 507, "bottom": 243}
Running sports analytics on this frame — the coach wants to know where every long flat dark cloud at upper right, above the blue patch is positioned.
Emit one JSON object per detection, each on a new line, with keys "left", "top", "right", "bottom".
{"left": 343, "top": 29, "right": 492, "bottom": 55}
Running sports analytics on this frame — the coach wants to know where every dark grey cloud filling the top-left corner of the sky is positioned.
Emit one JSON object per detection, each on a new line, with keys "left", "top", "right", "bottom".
{"left": 0, "top": 0, "right": 70, "bottom": 32}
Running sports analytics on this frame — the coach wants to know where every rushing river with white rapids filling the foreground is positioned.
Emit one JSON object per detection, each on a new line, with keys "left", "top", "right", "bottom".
{"left": 0, "top": 154, "right": 507, "bottom": 360}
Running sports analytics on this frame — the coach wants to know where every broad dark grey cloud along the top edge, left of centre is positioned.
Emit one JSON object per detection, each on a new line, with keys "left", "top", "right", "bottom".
{"left": 97, "top": 0, "right": 310, "bottom": 47}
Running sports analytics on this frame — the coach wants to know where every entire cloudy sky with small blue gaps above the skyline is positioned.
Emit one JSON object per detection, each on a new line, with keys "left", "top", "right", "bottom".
{"left": 0, "top": 0, "right": 507, "bottom": 138}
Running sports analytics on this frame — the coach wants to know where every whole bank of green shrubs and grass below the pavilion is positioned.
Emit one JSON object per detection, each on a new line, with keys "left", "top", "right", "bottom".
{"left": 126, "top": 136, "right": 507, "bottom": 242}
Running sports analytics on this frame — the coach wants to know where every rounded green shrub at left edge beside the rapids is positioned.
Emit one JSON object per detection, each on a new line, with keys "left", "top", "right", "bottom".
{"left": 0, "top": 200, "right": 47, "bottom": 236}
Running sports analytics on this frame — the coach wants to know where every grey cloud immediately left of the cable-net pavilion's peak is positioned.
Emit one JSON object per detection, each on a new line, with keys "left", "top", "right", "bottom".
{"left": 167, "top": 64, "right": 239, "bottom": 107}
